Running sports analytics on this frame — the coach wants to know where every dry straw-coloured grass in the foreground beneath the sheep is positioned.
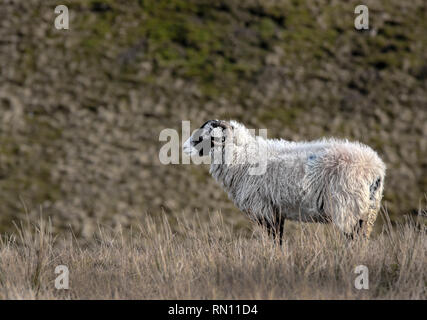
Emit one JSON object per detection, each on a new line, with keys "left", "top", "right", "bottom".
{"left": 0, "top": 214, "right": 427, "bottom": 299}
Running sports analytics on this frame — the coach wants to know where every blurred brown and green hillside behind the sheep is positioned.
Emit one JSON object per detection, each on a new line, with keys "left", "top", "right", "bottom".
{"left": 0, "top": 0, "right": 427, "bottom": 236}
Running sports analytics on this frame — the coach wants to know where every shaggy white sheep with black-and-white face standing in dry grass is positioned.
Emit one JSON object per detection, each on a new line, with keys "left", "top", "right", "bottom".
{"left": 183, "top": 120, "right": 386, "bottom": 243}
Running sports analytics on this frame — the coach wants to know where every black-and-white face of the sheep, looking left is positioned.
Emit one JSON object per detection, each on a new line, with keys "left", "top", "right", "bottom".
{"left": 183, "top": 120, "right": 231, "bottom": 157}
